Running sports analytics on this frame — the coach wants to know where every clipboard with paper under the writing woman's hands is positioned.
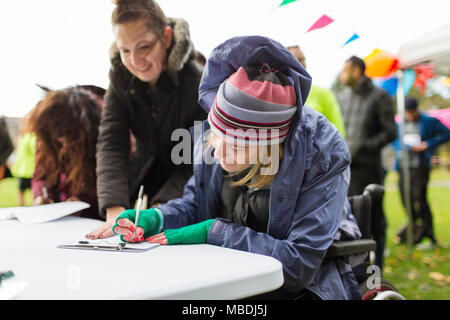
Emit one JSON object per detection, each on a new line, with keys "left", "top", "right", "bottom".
{"left": 57, "top": 238, "right": 159, "bottom": 252}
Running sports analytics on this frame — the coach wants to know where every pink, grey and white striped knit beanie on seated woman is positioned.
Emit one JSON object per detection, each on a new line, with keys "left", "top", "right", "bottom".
{"left": 208, "top": 64, "right": 297, "bottom": 145}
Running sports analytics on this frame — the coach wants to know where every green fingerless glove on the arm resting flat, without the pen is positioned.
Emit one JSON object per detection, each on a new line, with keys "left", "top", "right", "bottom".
{"left": 164, "top": 219, "right": 215, "bottom": 245}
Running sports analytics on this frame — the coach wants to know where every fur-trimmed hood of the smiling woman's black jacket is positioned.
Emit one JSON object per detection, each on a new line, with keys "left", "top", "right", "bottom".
{"left": 110, "top": 18, "right": 195, "bottom": 83}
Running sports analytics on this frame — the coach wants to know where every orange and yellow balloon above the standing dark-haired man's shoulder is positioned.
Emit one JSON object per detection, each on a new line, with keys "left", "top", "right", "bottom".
{"left": 364, "top": 49, "right": 398, "bottom": 78}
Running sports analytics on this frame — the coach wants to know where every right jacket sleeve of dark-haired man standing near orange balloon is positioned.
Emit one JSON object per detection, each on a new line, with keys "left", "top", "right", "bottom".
{"left": 363, "top": 92, "right": 397, "bottom": 150}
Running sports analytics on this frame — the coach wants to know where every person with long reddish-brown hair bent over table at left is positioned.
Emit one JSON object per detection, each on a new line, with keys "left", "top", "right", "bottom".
{"left": 28, "top": 86, "right": 101, "bottom": 219}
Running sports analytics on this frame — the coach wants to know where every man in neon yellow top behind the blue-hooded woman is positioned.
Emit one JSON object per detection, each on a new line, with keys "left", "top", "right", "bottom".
{"left": 287, "top": 46, "right": 345, "bottom": 138}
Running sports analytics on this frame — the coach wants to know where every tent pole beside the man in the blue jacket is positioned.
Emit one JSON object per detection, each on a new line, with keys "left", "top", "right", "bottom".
{"left": 396, "top": 70, "right": 414, "bottom": 258}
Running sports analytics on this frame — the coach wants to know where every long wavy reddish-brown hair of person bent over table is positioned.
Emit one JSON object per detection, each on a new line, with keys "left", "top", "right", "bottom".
{"left": 27, "top": 87, "right": 101, "bottom": 195}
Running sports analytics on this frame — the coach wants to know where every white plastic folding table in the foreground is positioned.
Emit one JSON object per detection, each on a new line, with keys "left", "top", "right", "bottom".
{"left": 0, "top": 217, "right": 283, "bottom": 299}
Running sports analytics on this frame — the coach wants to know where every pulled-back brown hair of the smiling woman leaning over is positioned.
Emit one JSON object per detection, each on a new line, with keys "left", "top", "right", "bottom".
{"left": 111, "top": 0, "right": 169, "bottom": 37}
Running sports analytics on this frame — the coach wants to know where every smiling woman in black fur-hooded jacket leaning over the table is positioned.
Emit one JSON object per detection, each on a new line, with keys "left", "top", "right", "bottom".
{"left": 86, "top": 0, "right": 207, "bottom": 239}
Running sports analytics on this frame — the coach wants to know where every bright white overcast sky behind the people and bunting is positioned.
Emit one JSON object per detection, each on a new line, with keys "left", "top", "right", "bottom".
{"left": 0, "top": 0, "right": 450, "bottom": 117}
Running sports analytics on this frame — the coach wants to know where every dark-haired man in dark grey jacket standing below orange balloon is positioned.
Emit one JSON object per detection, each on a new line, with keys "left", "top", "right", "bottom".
{"left": 338, "top": 56, "right": 396, "bottom": 269}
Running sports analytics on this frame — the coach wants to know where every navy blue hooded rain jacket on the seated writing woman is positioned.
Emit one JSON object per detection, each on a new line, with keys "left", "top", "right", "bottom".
{"left": 159, "top": 36, "right": 360, "bottom": 299}
